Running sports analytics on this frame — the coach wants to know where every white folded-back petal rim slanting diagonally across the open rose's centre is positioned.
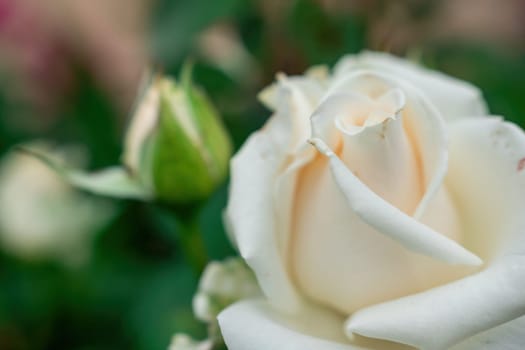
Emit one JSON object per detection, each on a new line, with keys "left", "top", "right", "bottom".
{"left": 311, "top": 139, "right": 482, "bottom": 266}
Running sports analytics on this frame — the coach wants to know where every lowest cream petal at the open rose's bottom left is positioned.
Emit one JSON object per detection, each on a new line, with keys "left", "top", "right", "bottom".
{"left": 218, "top": 300, "right": 364, "bottom": 350}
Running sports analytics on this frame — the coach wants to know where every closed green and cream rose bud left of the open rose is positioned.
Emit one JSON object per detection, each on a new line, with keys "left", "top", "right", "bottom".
{"left": 123, "top": 73, "right": 231, "bottom": 203}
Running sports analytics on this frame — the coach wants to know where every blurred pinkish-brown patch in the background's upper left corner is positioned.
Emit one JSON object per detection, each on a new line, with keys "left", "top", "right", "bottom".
{"left": 0, "top": 0, "right": 147, "bottom": 130}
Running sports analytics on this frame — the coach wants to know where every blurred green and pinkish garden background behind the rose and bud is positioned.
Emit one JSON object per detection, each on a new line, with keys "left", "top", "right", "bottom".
{"left": 0, "top": 0, "right": 525, "bottom": 350}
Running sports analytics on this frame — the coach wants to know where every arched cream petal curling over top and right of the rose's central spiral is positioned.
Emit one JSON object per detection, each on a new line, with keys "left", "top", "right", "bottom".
{"left": 311, "top": 69, "right": 447, "bottom": 219}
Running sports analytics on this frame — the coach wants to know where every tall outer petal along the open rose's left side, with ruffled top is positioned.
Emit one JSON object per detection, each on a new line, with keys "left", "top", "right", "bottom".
{"left": 226, "top": 71, "right": 322, "bottom": 309}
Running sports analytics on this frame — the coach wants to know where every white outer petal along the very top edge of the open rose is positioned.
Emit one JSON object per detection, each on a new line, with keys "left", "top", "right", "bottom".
{"left": 335, "top": 52, "right": 487, "bottom": 121}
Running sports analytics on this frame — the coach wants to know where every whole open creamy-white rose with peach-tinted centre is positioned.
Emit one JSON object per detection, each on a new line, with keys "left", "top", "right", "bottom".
{"left": 219, "top": 52, "right": 525, "bottom": 350}
